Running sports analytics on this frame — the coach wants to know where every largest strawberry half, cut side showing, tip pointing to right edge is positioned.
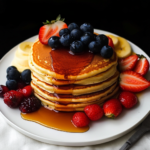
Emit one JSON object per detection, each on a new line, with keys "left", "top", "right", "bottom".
{"left": 119, "top": 71, "right": 150, "bottom": 92}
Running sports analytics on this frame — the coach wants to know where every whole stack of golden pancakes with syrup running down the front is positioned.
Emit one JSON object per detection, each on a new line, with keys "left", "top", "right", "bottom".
{"left": 29, "top": 41, "right": 119, "bottom": 111}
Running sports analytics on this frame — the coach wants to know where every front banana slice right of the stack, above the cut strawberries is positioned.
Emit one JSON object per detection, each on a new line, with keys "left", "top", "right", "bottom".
{"left": 114, "top": 37, "right": 132, "bottom": 58}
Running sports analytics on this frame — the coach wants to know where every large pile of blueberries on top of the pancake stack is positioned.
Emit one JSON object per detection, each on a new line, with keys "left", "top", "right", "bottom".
{"left": 48, "top": 23, "right": 113, "bottom": 58}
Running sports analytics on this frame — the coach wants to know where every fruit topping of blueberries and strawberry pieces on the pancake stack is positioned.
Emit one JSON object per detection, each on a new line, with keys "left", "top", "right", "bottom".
{"left": 39, "top": 16, "right": 113, "bottom": 59}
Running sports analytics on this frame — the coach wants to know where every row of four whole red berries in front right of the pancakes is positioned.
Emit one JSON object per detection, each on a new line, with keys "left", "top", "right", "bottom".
{"left": 72, "top": 91, "right": 138, "bottom": 127}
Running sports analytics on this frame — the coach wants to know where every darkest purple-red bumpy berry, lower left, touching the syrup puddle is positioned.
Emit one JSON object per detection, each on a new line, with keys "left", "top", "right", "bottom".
{"left": 19, "top": 96, "right": 41, "bottom": 113}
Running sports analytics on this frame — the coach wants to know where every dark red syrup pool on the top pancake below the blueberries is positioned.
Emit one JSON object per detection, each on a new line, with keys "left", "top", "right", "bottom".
{"left": 50, "top": 48, "right": 94, "bottom": 80}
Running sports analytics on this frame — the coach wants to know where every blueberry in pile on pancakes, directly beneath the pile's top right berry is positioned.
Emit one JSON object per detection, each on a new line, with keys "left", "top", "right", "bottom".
{"left": 80, "top": 33, "right": 93, "bottom": 46}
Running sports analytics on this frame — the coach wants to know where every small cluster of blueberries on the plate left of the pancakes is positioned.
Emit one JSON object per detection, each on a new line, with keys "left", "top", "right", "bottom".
{"left": 6, "top": 66, "right": 31, "bottom": 90}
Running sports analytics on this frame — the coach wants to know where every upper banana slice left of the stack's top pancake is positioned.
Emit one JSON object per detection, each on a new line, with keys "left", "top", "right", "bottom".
{"left": 18, "top": 42, "right": 33, "bottom": 55}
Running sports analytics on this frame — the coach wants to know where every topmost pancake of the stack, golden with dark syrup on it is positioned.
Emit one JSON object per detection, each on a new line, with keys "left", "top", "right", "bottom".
{"left": 31, "top": 41, "right": 117, "bottom": 80}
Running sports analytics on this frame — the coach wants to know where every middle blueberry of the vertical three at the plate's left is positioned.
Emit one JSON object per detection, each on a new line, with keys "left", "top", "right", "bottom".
{"left": 7, "top": 69, "right": 20, "bottom": 81}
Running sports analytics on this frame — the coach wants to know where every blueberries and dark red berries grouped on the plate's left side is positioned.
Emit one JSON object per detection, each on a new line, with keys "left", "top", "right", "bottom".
{"left": 0, "top": 66, "right": 41, "bottom": 113}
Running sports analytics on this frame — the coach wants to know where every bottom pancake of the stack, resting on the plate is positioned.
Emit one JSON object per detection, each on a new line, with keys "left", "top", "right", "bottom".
{"left": 35, "top": 87, "right": 119, "bottom": 111}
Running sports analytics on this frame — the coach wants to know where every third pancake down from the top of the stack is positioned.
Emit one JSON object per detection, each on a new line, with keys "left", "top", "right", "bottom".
{"left": 32, "top": 71, "right": 119, "bottom": 95}
